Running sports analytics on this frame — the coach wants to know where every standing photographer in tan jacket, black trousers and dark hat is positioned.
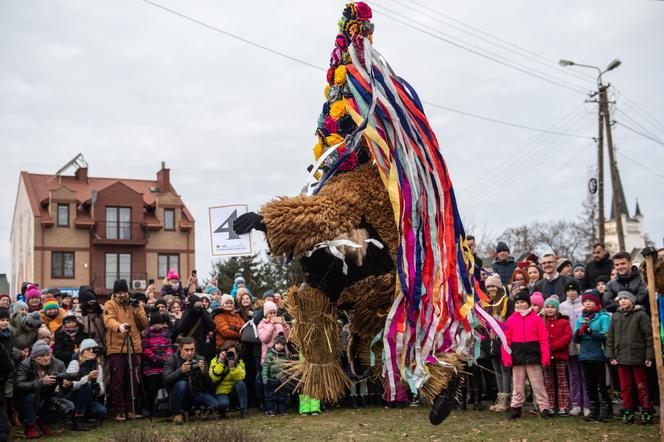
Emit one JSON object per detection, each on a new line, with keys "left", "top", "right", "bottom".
{"left": 104, "top": 279, "right": 148, "bottom": 422}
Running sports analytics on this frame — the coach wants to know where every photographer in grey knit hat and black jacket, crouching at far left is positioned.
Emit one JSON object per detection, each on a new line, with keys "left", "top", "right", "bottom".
{"left": 14, "top": 340, "right": 74, "bottom": 439}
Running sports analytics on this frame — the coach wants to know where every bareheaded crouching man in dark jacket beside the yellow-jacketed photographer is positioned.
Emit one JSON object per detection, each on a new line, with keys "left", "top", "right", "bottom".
{"left": 164, "top": 337, "right": 217, "bottom": 425}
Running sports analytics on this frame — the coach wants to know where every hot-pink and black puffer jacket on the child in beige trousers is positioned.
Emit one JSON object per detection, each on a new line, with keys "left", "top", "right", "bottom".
{"left": 501, "top": 310, "right": 551, "bottom": 367}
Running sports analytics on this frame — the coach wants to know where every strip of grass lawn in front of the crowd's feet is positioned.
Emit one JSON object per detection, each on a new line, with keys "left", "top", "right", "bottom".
{"left": 10, "top": 407, "right": 659, "bottom": 442}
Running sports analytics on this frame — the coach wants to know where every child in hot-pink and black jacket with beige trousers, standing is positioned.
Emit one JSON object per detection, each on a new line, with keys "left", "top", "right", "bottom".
{"left": 502, "top": 289, "right": 555, "bottom": 419}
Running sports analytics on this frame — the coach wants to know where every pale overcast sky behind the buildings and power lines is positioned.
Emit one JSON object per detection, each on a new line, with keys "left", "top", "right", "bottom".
{"left": 0, "top": 0, "right": 664, "bottom": 286}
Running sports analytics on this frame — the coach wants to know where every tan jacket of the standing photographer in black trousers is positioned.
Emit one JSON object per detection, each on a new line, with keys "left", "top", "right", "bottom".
{"left": 104, "top": 295, "right": 148, "bottom": 355}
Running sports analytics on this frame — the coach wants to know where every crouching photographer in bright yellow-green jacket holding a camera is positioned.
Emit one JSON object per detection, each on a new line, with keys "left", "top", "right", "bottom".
{"left": 210, "top": 341, "right": 249, "bottom": 419}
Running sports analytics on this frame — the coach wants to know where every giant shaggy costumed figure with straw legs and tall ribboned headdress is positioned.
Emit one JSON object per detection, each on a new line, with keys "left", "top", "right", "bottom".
{"left": 234, "top": 2, "right": 504, "bottom": 424}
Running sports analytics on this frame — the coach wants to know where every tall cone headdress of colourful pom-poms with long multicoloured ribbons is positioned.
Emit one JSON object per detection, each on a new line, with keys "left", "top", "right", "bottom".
{"left": 308, "top": 2, "right": 504, "bottom": 398}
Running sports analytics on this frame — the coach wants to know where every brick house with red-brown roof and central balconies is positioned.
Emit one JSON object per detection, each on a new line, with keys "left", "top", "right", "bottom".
{"left": 10, "top": 155, "right": 195, "bottom": 294}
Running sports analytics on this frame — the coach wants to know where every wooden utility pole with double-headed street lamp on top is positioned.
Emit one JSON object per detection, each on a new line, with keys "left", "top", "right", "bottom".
{"left": 558, "top": 58, "right": 625, "bottom": 251}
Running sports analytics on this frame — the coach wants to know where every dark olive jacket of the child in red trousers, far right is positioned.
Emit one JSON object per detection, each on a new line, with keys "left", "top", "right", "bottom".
{"left": 606, "top": 305, "right": 655, "bottom": 365}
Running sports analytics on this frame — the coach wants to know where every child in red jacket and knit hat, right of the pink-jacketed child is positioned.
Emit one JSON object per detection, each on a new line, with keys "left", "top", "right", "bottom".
{"left": 544, "top": 295, "right": 572, "bottom": 416}
